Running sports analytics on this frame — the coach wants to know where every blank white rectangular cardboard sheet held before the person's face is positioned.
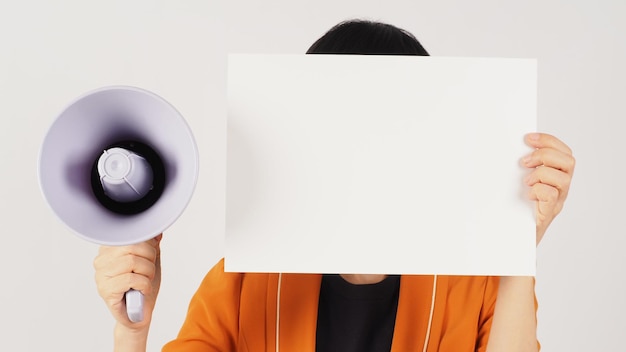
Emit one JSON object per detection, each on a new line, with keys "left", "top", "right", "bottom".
{"left": 225, "top": 55, "right": 536, "bottom": 275}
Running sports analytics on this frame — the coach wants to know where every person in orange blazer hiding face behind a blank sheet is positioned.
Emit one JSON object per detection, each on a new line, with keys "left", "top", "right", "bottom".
{"left": 94, "top": 20, "right": 575, "bottom": 352}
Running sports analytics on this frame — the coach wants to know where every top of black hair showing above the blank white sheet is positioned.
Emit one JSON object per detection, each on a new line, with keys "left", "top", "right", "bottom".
{"left": 306, "top": 20, "right": 429, "bottom": 56}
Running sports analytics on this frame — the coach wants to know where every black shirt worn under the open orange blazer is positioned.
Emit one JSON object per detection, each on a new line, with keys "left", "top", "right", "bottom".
{"left": 316, "top": 275, "right": 400, "bottom": 352}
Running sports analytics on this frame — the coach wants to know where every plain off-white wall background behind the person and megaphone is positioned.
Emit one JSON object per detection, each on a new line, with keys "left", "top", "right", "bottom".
{"left": 0, "top": 0, "right": 626, "bottom": 351}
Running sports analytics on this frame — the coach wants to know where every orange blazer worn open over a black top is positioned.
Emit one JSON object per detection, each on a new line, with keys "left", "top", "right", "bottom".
{"left": 163, "top": 259, "right": 499, "bottom": 352}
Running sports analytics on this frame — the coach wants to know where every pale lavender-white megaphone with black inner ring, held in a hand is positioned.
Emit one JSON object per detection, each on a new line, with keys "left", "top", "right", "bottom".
{"left": 39, "top": 86, "right": 198, "bottom": 322}
